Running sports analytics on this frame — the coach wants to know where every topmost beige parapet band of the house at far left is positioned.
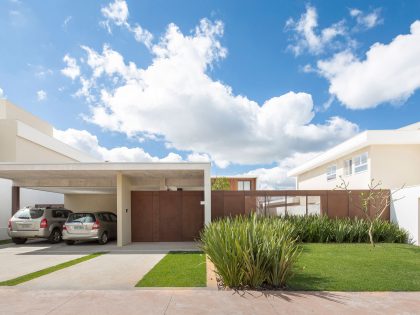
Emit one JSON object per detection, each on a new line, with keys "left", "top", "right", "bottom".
{"left": 0, "top": 100, "right": 53, "bottom": 137}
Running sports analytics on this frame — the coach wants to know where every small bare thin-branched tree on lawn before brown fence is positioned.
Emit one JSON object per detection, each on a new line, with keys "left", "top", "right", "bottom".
{"left": 336, "top": 176, "right": 404, "bottom": 247}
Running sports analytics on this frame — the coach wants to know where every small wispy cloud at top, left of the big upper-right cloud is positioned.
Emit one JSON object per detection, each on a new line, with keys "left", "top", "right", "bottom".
{"left": 286, "top": 5, "right": 346, "bottom": 55}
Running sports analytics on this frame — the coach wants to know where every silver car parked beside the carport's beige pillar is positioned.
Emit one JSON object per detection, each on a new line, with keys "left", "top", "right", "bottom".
{"left": 63, "top": 212, "right": 117, "bottom": 245}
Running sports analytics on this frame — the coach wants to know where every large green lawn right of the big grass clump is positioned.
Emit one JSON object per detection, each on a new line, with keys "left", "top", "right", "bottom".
{"left": 288, "top": 244, "right": 420, "bottom": 291}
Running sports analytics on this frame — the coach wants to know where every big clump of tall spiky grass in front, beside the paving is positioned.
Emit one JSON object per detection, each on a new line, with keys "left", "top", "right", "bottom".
{"left": 201, "top": 214, "right": 300, "bottom": 288}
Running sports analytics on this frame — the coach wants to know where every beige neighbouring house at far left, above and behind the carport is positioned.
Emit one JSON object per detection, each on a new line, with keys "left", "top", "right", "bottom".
{"left": 0, "top": 100, "right": 96, "bottom": 239}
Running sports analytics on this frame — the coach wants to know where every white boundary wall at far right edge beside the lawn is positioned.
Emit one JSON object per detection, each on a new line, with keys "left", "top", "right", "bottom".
{"left": 391, "top": 186, "right": 420, "bottom": 245}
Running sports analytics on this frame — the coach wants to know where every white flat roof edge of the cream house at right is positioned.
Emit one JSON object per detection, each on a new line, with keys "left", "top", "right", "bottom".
{"left": 287, "top": 129, "right": 420, "bottom": 177}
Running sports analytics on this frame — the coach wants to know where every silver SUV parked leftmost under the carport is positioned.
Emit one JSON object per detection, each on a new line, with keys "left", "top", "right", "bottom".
{"left": 7, "top": 207, "right": 72, "bottom": 244}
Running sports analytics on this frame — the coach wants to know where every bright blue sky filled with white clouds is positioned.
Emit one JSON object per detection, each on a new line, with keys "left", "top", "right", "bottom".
{"left": 0, "top": 0, "right": 420, "bottom": 189}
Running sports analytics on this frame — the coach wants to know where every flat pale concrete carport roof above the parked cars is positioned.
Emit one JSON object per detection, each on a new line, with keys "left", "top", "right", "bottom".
{"left": 0, "top": 162, "right": 210, "bottom": 192}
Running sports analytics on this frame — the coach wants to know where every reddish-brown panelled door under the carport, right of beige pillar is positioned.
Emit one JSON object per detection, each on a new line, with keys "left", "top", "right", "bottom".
{"left": 131, "top": 191, "right": 204, "bottom": 242}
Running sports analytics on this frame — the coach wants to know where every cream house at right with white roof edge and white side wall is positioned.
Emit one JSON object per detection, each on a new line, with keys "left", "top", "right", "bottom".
{"left": 288, "top": 122, "right": 420, "bottom": 244}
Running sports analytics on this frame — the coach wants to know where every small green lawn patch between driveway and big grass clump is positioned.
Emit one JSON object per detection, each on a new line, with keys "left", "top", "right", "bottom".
{"left": 136, "top": 252, "right": 206, "bottom": 287}
